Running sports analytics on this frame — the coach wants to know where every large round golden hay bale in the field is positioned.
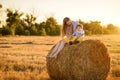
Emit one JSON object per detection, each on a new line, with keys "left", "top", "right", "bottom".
{"left": 46, "top": 40, "right": 110, "bottom": 80}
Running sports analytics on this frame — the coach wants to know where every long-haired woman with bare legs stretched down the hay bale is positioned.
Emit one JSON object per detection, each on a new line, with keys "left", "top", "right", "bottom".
{"left": 47, "top": 17, "right": 79, "bottom": 58}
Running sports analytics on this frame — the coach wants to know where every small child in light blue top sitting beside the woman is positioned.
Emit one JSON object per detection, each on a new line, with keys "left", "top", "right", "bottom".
{"left": 69, "top": 24, "right": 85, "bottom": 45}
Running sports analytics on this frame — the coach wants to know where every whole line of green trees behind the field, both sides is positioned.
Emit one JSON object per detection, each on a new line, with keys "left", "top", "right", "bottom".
{"left": 0, "top": 6, "right": 120, "bottom": 36}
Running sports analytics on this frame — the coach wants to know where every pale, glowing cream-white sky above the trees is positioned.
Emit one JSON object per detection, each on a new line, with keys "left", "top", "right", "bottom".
{"left": 0, "top": 0, "right": 120, "bottom": 27}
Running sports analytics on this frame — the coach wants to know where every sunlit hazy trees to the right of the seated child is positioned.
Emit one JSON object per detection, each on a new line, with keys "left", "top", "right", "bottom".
{"left": 78, "top": 19, "right": 119, "bottom": 35}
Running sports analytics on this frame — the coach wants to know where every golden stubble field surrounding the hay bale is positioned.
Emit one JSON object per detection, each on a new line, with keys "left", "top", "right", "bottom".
{"left": 0, "top": 35, "right": 120, "bottom": 80}
